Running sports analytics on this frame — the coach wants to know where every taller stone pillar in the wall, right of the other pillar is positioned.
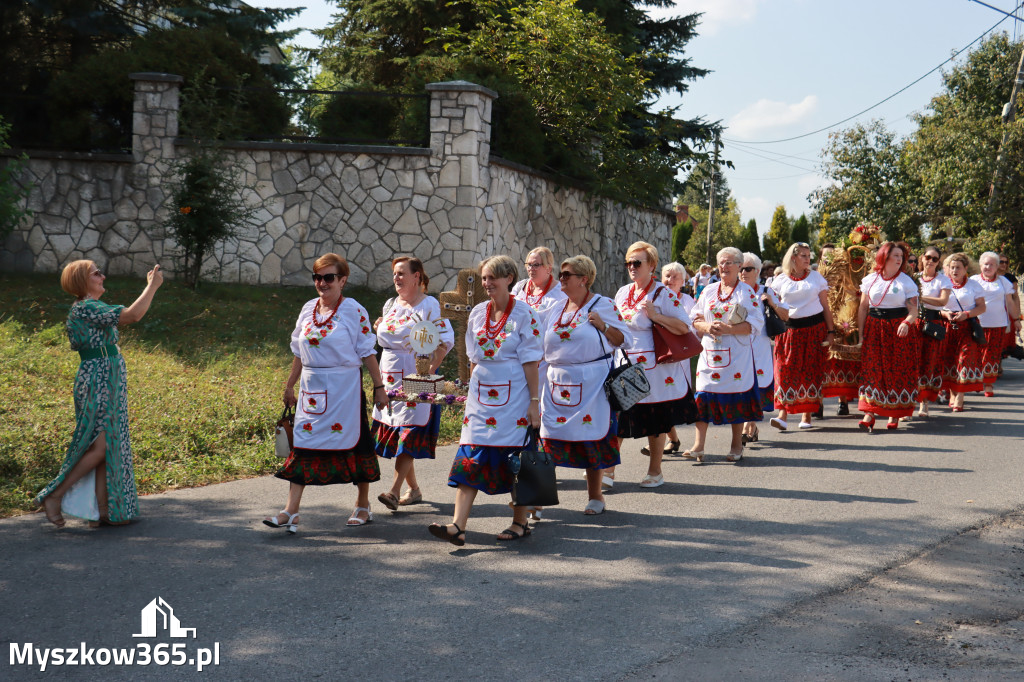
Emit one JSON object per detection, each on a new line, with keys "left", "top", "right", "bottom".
{"left": 427, "top": 81, "right": 498, "bottom": 269}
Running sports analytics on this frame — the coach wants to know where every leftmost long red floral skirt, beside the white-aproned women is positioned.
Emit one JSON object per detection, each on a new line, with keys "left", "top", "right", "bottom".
{"left": 775, "top": 321, "right": 828, "bottom": 414}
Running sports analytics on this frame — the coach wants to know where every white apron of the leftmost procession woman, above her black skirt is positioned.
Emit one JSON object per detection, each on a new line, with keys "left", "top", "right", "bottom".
{"left": 294, "top": 367, "right": 362, "bottom": 450}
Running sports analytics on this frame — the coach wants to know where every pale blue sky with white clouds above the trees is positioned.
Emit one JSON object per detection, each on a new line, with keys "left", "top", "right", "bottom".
{"left": 253, "top": 0, "right": 1022, "bottom": 233}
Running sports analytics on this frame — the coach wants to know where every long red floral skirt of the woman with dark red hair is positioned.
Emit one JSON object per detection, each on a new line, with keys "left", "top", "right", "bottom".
{"left": 857, "top": 315, "right": 921, "bottom": 418}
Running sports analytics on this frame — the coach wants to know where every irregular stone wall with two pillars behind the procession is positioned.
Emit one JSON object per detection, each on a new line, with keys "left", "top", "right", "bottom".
{"left": 0, "top": 74, "right": 674, "bottom": 293}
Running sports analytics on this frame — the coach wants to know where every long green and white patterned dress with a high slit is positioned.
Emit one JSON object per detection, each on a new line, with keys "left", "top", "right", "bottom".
{"left": 36, "top": 299, "right": 138, "bottom": 522}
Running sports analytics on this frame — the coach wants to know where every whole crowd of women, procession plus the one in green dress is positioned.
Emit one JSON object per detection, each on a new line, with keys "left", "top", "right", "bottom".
{"left": 36, "top": 242, "right": 1021, "bottom": 546}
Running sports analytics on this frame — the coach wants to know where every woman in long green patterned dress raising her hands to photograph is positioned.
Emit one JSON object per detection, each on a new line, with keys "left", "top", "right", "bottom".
{"left": 36, "top": 260, "right": 164, "bottom": 528}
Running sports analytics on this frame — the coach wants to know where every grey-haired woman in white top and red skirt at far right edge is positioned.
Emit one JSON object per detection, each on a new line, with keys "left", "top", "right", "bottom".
{"left": 971, "top": 251, "right": 1021, "bottom": 397}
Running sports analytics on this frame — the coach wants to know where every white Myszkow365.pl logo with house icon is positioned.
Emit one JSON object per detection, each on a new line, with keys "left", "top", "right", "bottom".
{"left": 10, "top": 597, "right": 220, "bottom": 672}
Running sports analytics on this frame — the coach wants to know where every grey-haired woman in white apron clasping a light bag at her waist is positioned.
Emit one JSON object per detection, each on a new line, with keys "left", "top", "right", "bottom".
{"left": 683, "top": 247, "right": 764, "bottom": 462}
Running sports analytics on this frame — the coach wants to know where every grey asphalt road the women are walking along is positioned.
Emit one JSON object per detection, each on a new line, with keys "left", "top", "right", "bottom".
{"left": 0, "top": 360, "right": 1024, "bottom": 681}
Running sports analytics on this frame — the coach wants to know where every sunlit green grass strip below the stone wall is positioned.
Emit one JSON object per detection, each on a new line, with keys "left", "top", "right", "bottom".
{"left": 0, "top": 274, "right": 462, "bottom": 516}
